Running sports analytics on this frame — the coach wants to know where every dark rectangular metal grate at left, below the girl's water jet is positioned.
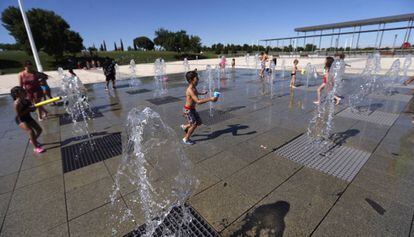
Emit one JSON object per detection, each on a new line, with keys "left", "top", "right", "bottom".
{"left": 61, "top": 133, "right": 122, "bottom": 173}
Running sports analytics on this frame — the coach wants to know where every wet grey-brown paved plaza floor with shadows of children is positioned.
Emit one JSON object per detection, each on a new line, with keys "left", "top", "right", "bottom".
{"left": 0, "top": 69, "right": 414, "bottom": 237}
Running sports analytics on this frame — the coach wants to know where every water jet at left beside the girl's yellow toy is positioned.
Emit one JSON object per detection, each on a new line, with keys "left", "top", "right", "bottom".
{"left": 58, "top": 68, "right": 93, "bottom": 145}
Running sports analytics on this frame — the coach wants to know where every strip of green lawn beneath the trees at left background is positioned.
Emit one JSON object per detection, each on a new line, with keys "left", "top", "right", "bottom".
{"left": 0, "top": 50, "right": 213, "bottom": 74}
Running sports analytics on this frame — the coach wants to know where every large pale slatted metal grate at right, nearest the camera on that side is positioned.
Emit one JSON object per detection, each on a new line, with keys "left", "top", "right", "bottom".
{"left": 275, "top": 134, "right": 371, "bottom": 182}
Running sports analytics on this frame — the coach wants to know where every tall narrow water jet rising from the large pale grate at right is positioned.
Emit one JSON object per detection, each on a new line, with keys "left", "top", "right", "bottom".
{"left": 307, "top": 60, "right": 345, "bottom": 146}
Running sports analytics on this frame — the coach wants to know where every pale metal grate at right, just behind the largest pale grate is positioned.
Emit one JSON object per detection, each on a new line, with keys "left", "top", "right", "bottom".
{"left": 338, "top": 108, "right": 399, "bottom": 126}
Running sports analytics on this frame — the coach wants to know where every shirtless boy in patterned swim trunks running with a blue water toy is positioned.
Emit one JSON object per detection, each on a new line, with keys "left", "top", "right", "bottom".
{"left": 181, "top": 71, "right": 218, "bottom": 145}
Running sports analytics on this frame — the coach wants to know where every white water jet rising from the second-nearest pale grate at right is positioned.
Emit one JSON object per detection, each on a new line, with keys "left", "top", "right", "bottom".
{"left": 349, "top": 52, "right": 381, "bottom": 113}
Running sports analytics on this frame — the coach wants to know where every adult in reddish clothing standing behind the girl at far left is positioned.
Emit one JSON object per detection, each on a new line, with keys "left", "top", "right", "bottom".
{"left": 19, "top": 60, "right": 47, "bottom": 121}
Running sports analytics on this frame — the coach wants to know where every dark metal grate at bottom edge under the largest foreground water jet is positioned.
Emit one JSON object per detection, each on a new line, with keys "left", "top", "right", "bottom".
{"left": 124, "top": 206, "right": 220, "bottom": 237}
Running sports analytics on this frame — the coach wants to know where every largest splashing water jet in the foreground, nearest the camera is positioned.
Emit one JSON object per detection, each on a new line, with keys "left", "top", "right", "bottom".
{"left": 110, "top": 107, "right": 198, "bottom": 236}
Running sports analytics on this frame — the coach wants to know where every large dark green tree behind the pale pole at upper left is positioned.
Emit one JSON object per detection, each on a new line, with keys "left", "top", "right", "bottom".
{"left": 1, "top": 6, "right": 83, "bottom": 59}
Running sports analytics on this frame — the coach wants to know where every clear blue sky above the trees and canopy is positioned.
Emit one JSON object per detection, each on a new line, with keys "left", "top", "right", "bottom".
{"left": 0, "top": 0, "right": 414, "bottom": 48}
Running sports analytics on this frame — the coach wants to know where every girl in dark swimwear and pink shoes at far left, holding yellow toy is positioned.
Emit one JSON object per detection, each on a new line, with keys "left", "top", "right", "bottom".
{"left": 10, "top": 86, "right": 45, "bottom": 154}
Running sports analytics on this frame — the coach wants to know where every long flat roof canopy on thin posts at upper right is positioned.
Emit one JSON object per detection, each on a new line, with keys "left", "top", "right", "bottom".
{"left": 295, "top": 13, "right": 414, "bottom": 32}
